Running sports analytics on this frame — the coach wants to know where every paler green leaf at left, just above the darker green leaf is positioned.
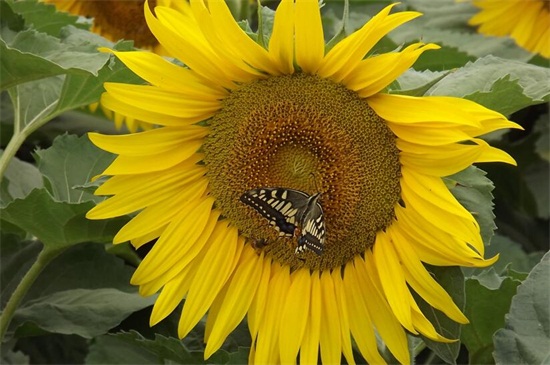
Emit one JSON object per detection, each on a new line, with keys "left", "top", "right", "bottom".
{"left": 35, "top": 135, "right": 114, "bottom": 203}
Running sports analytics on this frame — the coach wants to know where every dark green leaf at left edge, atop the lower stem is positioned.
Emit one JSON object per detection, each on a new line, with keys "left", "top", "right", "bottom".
{"left": 0, "top": 189, "right": 128, "bottom": 248}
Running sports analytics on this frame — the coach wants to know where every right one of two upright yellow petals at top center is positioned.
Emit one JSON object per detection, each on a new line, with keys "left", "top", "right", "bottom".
{"left": 294, "top": 0, "right": 325, "bottom": 74}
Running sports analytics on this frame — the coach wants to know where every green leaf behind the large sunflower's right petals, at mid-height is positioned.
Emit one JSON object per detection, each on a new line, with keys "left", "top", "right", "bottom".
{"left": 445, "top": 166, "right": 496, "bottom": 245}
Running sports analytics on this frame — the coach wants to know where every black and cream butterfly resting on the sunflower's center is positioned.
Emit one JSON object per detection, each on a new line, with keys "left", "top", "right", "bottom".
{"left": 240, "top": 188, "right": 326, "bottom": 255}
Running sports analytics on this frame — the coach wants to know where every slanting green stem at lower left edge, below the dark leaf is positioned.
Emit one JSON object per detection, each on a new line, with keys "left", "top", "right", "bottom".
{"left": 0, "top": 248, "right": 63, "bottom": 343}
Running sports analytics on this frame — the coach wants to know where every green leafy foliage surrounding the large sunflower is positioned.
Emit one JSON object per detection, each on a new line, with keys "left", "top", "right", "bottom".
{"left": 0, "top": 0, "right": 550, "bottom": 364}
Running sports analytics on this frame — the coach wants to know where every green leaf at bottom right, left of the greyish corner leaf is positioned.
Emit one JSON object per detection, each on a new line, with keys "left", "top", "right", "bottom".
{"left": 460, "top": 268, "right": 521, "bottom": 364}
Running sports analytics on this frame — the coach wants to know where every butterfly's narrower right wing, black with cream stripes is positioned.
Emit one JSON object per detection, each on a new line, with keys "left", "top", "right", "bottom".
{"left": 295, "top": 200, "right": 326, "bottom": 255}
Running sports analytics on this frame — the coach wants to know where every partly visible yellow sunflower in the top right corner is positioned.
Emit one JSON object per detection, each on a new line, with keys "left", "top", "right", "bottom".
{"left": 468, "top": 0, "right": 550, "bottom": 58}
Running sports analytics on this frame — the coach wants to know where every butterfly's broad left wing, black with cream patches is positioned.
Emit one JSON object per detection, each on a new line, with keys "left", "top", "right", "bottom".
{"left": 240, "top": 188, "right": 309, "bottom": 237}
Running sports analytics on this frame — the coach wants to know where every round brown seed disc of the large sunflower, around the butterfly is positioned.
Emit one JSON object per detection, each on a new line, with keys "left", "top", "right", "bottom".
{"left": 204, "top": 73, "right": 401, "bottom": 269}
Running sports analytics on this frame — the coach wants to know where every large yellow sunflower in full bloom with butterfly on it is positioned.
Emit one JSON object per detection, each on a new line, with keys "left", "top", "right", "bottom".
{"left": 88, "top": 0, "right": 519, "bottom": 364}
